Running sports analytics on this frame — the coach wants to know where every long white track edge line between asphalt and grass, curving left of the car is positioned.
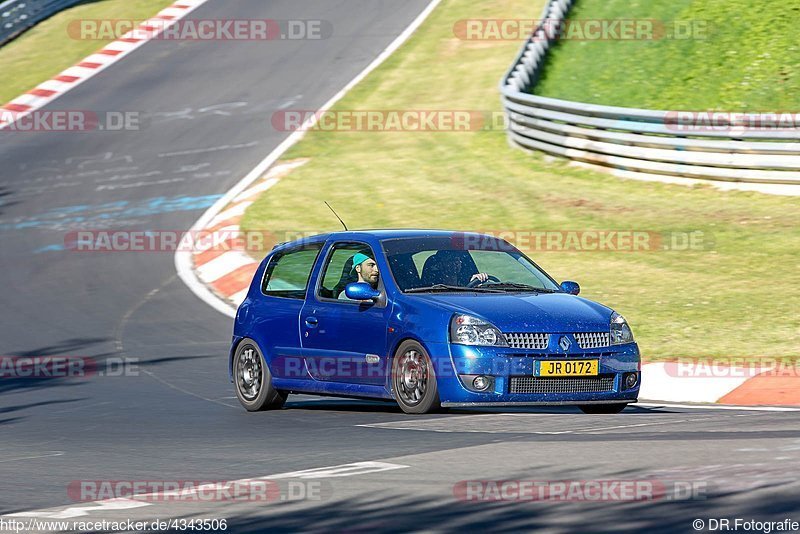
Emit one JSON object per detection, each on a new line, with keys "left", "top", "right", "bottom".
{"left": 175, "top": 0, "right": 441, "bottom": 317}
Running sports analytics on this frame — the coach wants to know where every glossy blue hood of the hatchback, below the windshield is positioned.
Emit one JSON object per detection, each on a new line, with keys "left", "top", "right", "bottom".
{"left": 414, "top": 293, "right": 612, "bottom": 332}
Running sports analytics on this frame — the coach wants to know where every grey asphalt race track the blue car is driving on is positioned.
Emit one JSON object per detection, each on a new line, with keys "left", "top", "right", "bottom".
{"left": 0, "top": 0, "right": 800, "bottom": 532}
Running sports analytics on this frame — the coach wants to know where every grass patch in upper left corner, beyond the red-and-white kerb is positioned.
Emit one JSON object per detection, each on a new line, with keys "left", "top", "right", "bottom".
{"left": 0, "top": 0, "right": 173, "bottom": 103}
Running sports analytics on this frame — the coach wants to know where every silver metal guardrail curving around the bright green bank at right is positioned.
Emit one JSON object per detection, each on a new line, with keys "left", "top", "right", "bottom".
{"left": 500, "top": 0, "right": 800, "bottom": 184}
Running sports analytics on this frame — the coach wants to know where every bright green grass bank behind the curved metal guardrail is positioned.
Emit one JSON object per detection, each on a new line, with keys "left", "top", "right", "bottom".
{"left": 533, "top": 0, "right": 800, "bottom": 111}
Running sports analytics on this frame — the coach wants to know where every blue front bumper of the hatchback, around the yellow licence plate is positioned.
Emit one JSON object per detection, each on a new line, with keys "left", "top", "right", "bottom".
{"left": 428, "top": 343, "right": 641, "bottom": 406}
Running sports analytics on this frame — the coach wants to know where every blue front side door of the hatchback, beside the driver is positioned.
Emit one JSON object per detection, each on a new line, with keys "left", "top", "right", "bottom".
{"left": 300, "top": 241, "right": 391, "bottom": 385}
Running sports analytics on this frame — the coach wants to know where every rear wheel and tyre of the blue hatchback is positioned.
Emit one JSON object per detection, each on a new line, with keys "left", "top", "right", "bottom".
{"left": 233, "top": 338, "right": 286, "bottom": 412}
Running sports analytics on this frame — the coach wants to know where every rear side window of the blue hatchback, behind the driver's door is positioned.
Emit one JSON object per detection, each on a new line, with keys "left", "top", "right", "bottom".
{"left": 261, "top": 243, "right": 322, "bottom": 299}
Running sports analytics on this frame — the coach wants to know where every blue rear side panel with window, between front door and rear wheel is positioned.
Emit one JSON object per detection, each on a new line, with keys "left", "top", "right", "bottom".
{"left": 252, "top": 242, "right": 324, "bottom": 378}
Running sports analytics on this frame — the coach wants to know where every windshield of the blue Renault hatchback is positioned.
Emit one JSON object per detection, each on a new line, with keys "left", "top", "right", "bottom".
{"left": 382, "top": 234, "right": 561, "bottom": 293}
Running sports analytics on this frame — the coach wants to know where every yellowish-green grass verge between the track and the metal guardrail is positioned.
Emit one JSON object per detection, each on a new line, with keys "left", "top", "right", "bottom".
{"left": 243, "top": 0, "right": 800, "bottom": 359}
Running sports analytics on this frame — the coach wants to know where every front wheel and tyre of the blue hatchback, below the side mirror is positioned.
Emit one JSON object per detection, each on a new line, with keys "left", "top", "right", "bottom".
{"left": 392, "top": 340, "right": 441, "bottom": 414}
